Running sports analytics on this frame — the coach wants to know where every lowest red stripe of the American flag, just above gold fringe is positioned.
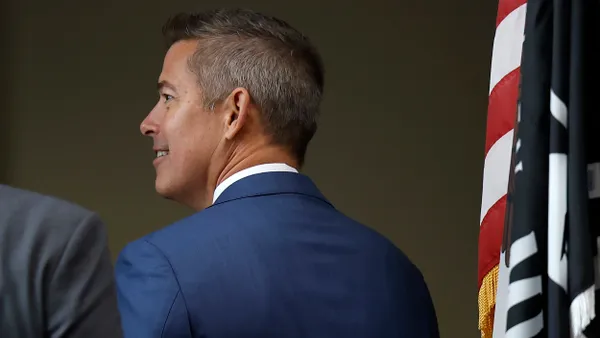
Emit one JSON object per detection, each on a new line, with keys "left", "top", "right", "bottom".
{"left": 477, "top": 195, "right": 506, "bottom": 289}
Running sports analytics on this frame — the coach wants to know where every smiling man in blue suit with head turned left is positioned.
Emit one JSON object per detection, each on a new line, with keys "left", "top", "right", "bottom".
{"left": 116, "top": 9, "right": 439, "bottom": 338}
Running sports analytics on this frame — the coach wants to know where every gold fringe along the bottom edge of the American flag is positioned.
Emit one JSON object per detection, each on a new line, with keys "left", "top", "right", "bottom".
{"left": 478, "top": 265, "right": 498, "bottom": 338}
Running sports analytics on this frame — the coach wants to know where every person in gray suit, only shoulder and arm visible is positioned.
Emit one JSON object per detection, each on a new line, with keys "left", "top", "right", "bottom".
{"left": 0, "top": 185, "right": 122, "bottom": 338}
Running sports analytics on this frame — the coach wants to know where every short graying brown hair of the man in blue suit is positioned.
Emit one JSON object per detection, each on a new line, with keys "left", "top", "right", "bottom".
{"left": 163, "top": 9, "right": 324, "bottom": 164}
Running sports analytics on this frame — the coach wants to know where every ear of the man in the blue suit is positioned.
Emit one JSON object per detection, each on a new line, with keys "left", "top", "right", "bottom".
{"left": 223, "top": 88, "right": 251, "bottom": 140}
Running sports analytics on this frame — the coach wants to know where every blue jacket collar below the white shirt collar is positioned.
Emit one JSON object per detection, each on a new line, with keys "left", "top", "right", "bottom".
{"left": 213, "top": 172, "right": 331, "bottom": 205}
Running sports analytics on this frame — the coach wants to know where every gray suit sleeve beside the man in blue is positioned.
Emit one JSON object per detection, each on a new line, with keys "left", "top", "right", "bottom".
{"left": 45, "top": 213, "right": 122, "bottom": 338}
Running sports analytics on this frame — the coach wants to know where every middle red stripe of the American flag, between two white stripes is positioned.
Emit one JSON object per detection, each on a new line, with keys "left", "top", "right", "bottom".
{"left": 485, "top": 68, "right": 520, "bottom": 156}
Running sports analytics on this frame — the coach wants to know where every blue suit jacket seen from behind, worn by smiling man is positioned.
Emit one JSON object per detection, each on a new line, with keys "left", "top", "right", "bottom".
{"left": 116, "top": 172, "right": 439, "bottom": 338}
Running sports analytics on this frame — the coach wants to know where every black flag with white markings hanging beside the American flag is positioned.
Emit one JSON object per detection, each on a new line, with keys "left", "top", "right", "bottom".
{"left": 495, "top": 0, "right": 600, "bottom": 338}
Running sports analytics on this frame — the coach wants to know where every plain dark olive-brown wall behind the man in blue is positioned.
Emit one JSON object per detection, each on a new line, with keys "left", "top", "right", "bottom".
{"left": 0, "top": 0, "right": 496, "bottom": 338}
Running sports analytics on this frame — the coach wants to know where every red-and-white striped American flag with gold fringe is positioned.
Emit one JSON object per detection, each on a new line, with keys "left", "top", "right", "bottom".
{"left": 478, "top": 0, "right": 527, "bottom": 338}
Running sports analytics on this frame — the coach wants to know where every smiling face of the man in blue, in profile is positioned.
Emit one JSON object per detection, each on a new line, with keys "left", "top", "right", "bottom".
{"left": 140, "top": 41, "right": 222, "bottom": 201}
